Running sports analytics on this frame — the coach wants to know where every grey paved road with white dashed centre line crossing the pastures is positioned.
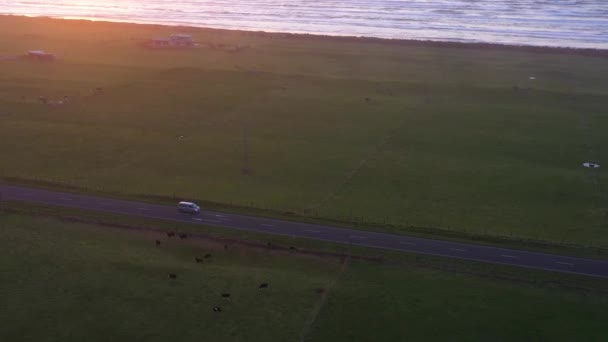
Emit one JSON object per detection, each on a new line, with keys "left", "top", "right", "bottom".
{"left": 0, "top": 185, "right": 608, "bottom": 278}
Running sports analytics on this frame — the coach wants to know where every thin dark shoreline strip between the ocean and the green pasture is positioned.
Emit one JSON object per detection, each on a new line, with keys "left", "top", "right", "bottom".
{"left": 0, "top": 14, "right": 608, "bottom": 58}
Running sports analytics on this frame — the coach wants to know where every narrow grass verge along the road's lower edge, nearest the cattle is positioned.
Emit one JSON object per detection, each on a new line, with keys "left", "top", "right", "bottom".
{"left": 4, "top": 203, "right": 608, "bottom": 292}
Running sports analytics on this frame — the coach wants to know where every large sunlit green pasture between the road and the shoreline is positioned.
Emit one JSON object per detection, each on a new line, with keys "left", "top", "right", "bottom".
{"left": 0, "top": 17, "right": 608, "bottom": 247}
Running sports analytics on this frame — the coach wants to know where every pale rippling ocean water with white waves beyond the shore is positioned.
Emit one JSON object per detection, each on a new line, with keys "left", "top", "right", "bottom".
{"left": 0, "top": 0, "right": 608, "bottom": 49}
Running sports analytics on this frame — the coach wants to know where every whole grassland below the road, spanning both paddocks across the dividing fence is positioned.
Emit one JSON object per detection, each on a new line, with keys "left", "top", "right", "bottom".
{"left": 0, "top": 214, "right": 608, "bottom": 341}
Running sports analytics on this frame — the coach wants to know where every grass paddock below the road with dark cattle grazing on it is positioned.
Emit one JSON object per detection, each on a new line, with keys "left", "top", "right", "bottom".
{"left": 0, "top": 216, "right": 338, "bottom": 341}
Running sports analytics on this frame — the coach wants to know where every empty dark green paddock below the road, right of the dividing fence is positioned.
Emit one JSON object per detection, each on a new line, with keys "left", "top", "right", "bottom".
{"left": 311, "top": 263, "right": 608, "bottom": 341}
